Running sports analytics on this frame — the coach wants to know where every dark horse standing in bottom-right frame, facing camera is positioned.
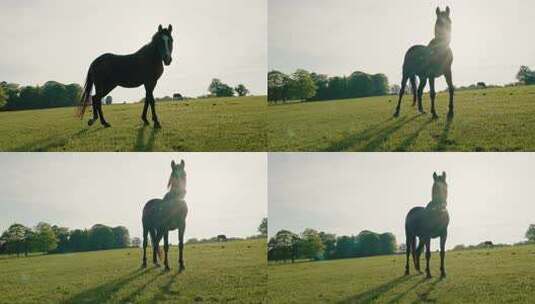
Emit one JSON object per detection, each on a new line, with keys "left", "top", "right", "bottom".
{"left": 405, "top": 172, "right": 450, "bottom": 279}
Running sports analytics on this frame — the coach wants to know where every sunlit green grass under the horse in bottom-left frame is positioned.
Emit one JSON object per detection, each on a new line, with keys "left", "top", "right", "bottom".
{"left": 0, "top": 240, "right": 267, "bottom": 304}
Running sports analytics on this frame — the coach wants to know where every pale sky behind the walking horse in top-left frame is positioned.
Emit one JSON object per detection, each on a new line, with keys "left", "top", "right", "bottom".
{"left": 0, "top": 0, "right": 267, "bottom": 102}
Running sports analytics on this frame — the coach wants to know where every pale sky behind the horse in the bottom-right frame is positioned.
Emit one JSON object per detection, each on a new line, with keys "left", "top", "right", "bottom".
{"left": 268, "top": 153, "right": 535, "bottom": 248}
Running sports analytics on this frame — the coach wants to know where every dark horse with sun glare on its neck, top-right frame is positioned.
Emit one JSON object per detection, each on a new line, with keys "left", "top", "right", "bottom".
{"left": 394, "top": 7, "right": 455, "bottom": 120}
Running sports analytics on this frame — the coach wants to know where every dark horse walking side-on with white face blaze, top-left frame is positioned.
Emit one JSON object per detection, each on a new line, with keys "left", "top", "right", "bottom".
{"left": 78, "top": 24, "right": 173, "bottom": 128}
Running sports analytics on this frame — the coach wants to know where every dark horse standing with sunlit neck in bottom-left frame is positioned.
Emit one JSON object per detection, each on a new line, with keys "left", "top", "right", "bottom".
{"left": 142, "top": 160, "right": 188, "bottom": 272}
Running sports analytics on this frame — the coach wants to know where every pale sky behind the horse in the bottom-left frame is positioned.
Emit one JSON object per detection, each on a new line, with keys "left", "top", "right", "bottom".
{"left": 0, "top": 153, "right": 267, "bottom": 244}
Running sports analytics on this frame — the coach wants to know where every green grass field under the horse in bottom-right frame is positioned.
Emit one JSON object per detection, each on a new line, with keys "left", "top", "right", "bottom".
{"left": 268, "top": 245, "right": 535, "bottom": 304}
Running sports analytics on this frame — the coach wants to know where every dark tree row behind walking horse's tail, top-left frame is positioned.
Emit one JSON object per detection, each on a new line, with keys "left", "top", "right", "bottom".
{"left": 0, "top": 81, "right": 82, "bottom": 111}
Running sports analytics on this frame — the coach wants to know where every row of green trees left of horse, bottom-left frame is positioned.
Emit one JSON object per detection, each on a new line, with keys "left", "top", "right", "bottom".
{"left": 0, "top": 222, "right": 131, "bottom": 256}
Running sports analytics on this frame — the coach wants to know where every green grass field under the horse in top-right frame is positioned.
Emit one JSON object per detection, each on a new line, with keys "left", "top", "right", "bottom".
{"left": 268, "top": 86, "right": 535, "bottom": 151}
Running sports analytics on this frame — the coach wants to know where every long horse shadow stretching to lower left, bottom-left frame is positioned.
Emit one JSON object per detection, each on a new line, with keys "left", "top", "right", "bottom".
{"left": 63, "top": 269, "right": 165, "bottom": 304}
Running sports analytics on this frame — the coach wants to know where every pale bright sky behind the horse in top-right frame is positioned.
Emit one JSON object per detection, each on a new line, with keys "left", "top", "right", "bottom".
{"left": 268, "top": 0, "right": 535, "bottom": 89}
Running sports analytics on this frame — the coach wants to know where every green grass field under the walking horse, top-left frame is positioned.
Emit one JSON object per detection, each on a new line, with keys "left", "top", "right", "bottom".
{"left": 0, "top": 96, "right": 268, "bottom": 152}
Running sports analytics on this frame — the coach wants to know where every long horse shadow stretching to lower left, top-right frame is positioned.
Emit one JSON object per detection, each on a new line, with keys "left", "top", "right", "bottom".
{"left": 324, "top": 115, "right": 420, "bottom": 152}
